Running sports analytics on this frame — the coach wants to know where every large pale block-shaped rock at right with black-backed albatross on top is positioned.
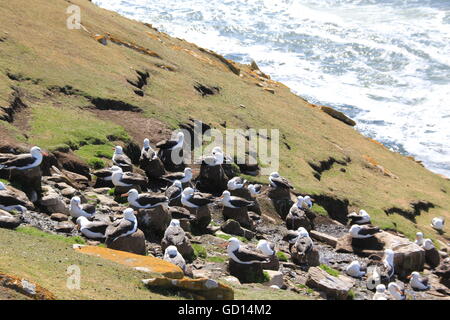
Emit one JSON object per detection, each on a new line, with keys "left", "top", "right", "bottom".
{"left": 336, "top": 231, "right": 425, "bottom": 278}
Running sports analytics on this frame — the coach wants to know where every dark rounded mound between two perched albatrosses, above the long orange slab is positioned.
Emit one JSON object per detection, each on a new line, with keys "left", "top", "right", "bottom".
{"left": 136, "top": 206, "right": 172, "bottom": 242}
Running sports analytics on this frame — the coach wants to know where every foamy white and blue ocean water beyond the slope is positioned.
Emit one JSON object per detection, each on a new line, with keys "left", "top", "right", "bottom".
{"left": 93, "top": 0, "right": 450, "bottom": 177}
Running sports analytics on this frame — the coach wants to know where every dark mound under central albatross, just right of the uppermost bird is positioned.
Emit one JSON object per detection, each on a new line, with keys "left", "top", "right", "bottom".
{"left": 197, "top": 164, "right": 228, "bottom": 194}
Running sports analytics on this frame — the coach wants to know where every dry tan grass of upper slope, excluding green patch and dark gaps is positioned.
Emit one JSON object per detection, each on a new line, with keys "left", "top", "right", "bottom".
{"left": 0, "top": 0, "right": 450, "bottom": 245}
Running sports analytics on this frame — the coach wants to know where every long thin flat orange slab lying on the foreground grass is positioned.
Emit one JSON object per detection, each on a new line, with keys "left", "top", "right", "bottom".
{"left": 74, "top": 245, "right": 184, "bottom": 279}
